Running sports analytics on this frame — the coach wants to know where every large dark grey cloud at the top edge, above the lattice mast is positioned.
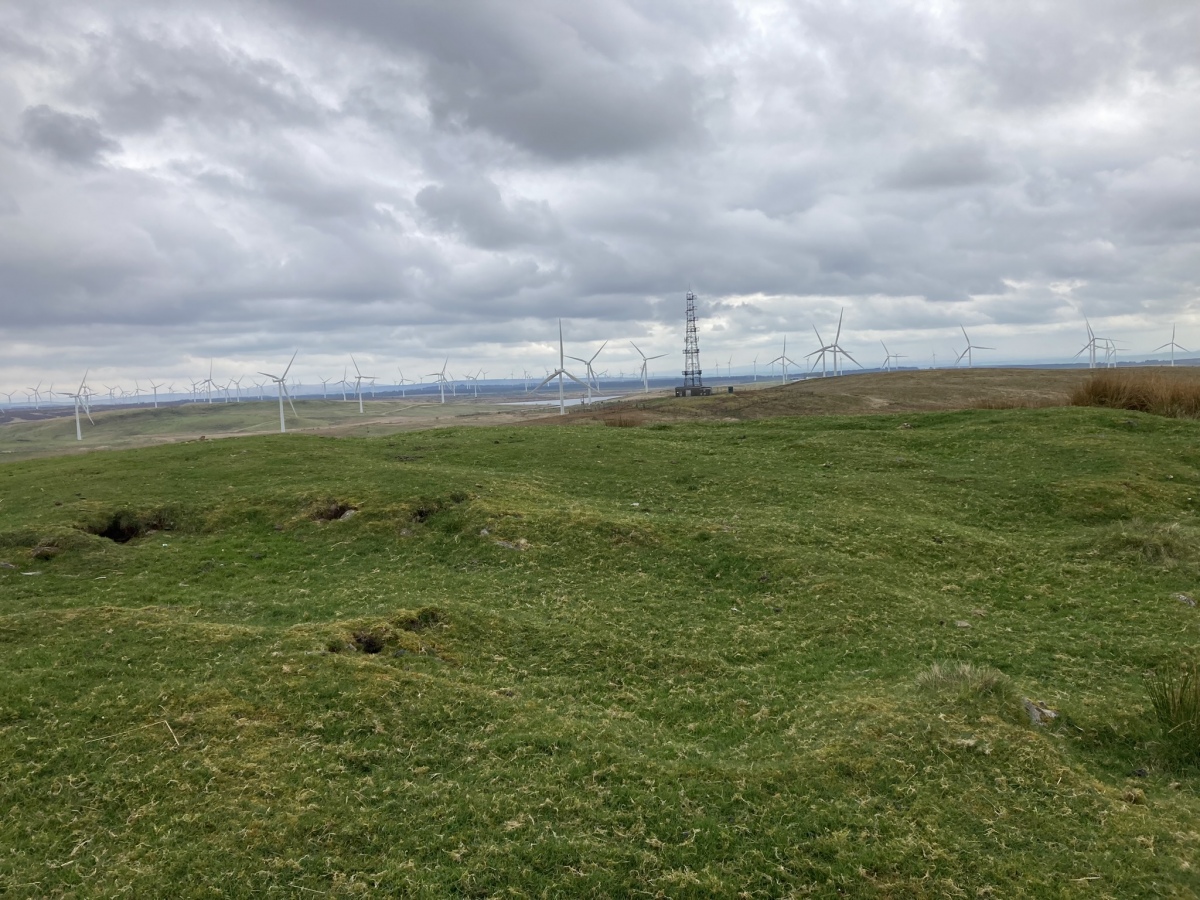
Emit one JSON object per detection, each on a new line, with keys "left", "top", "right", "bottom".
{"left": 277, "top": 0, "right": 706, "bottom": 161}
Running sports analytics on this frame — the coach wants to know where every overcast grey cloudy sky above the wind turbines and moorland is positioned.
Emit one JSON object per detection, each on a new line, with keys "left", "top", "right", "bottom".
{"left": 0, "top": 0, "right": 1200, "bottom": 391}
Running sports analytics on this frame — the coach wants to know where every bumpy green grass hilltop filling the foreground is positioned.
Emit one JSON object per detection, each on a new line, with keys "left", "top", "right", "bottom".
{"left": 0, "top": 408, "right": 1200, "bottom": 898}
